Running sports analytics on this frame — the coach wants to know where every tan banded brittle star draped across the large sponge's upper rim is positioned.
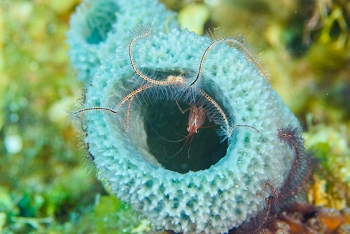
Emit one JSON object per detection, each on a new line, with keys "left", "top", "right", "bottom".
{"left": 73, "top": 25, "right": 266, "bottom": 137}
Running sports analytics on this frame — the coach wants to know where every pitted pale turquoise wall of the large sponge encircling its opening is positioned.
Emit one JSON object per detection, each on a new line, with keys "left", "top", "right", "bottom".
{"left": 80, "top": 26, "right": 300, "bottom": 233}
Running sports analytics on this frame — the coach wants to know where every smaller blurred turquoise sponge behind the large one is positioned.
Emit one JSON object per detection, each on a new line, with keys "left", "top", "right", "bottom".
{"left": 67, "top": 0, "right": 177, "bottom": 82}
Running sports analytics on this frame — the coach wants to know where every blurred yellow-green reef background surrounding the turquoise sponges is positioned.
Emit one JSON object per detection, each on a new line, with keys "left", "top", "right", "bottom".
{"left": 0, "top": 0, "right": 350, "bottom": 233}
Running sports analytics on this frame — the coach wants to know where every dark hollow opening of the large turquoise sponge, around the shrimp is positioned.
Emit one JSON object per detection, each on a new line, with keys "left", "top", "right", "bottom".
{"left": 144, "top": 98, "right": 228, "bottom": 174}
